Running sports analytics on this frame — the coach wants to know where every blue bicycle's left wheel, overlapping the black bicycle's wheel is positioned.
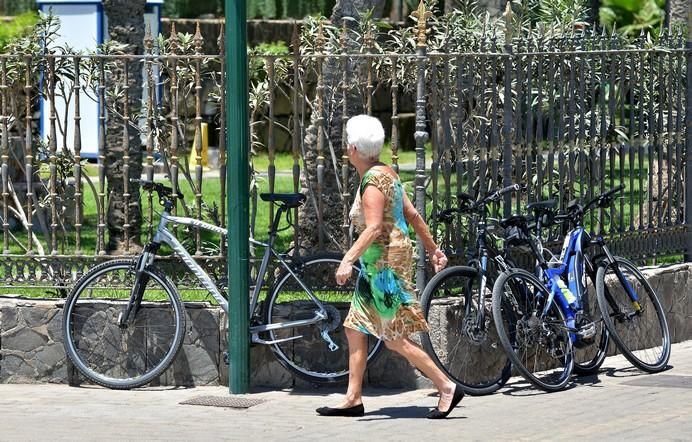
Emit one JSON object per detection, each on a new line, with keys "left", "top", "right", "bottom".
{"left": 493, "top": 269, "right": 574, "bottom": 392}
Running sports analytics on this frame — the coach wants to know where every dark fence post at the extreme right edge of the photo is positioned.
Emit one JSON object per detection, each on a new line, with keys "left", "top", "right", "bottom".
{"left": 685, "top": 9, "right": 692, "bottom": 262}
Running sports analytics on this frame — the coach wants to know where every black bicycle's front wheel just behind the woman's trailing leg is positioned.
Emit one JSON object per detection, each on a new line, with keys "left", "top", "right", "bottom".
{"left": 421, "top": 266, "right": 512, "bottom": 396}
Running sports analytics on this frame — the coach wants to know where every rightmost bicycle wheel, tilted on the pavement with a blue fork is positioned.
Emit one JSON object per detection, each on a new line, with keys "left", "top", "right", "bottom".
{"left": 596, "top": 257, "right": 671, "bottom": 373}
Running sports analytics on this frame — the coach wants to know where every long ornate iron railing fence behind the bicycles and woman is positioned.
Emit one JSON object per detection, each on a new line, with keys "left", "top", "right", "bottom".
{"left": 0, "top": 6, "right": 692, "bottom": 287}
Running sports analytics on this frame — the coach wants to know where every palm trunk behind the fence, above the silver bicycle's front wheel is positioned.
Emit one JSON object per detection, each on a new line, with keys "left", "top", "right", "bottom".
{"left": 103, "top": 0, "right": 146, "bottom": 254}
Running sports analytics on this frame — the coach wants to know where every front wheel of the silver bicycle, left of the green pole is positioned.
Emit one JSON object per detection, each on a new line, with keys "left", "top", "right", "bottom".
{"left": 63, "top": 260, "right": 185, "bottom": 389}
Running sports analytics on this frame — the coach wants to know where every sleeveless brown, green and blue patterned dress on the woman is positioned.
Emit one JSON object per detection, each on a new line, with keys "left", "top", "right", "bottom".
{"left": 344, "top": 169, "right": 428, "bottom": 341}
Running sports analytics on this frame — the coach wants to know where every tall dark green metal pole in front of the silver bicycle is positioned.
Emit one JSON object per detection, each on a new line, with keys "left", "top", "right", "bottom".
{"left": 225, "top": 0, "right": 250, "bottom": 394}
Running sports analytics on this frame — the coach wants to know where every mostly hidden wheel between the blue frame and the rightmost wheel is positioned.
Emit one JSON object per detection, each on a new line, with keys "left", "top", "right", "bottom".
{"left": 574, "top": 255, "right": 610, "bottom": 376}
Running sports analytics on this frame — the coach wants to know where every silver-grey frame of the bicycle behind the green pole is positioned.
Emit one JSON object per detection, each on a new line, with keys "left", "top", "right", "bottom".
{"left": 133, "top": 206, "right": 338, "bottom": 348}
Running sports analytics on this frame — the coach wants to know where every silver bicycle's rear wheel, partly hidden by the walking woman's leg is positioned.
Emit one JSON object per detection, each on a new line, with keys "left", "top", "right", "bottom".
{"left": 265, "top": 254, "right": 382, "bottom": 383}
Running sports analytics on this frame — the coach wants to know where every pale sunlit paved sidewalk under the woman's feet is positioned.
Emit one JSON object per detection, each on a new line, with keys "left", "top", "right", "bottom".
{"left": 0, "top": 341, "right": 692, "bottom": 441}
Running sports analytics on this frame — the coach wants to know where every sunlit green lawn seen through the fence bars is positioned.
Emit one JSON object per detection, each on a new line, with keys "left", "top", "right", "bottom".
{"left": 0, "top": 147, "right": 681, "bottom": 300}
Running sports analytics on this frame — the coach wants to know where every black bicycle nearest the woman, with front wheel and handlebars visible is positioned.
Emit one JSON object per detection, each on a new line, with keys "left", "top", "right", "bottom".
{"left": 421, "top": 185, "right": 519, "bottom": 395}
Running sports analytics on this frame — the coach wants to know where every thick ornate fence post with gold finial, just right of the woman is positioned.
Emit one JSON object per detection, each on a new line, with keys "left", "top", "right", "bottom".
{"left": 411, "top": 0, "right": 432, "bottom": 293}
